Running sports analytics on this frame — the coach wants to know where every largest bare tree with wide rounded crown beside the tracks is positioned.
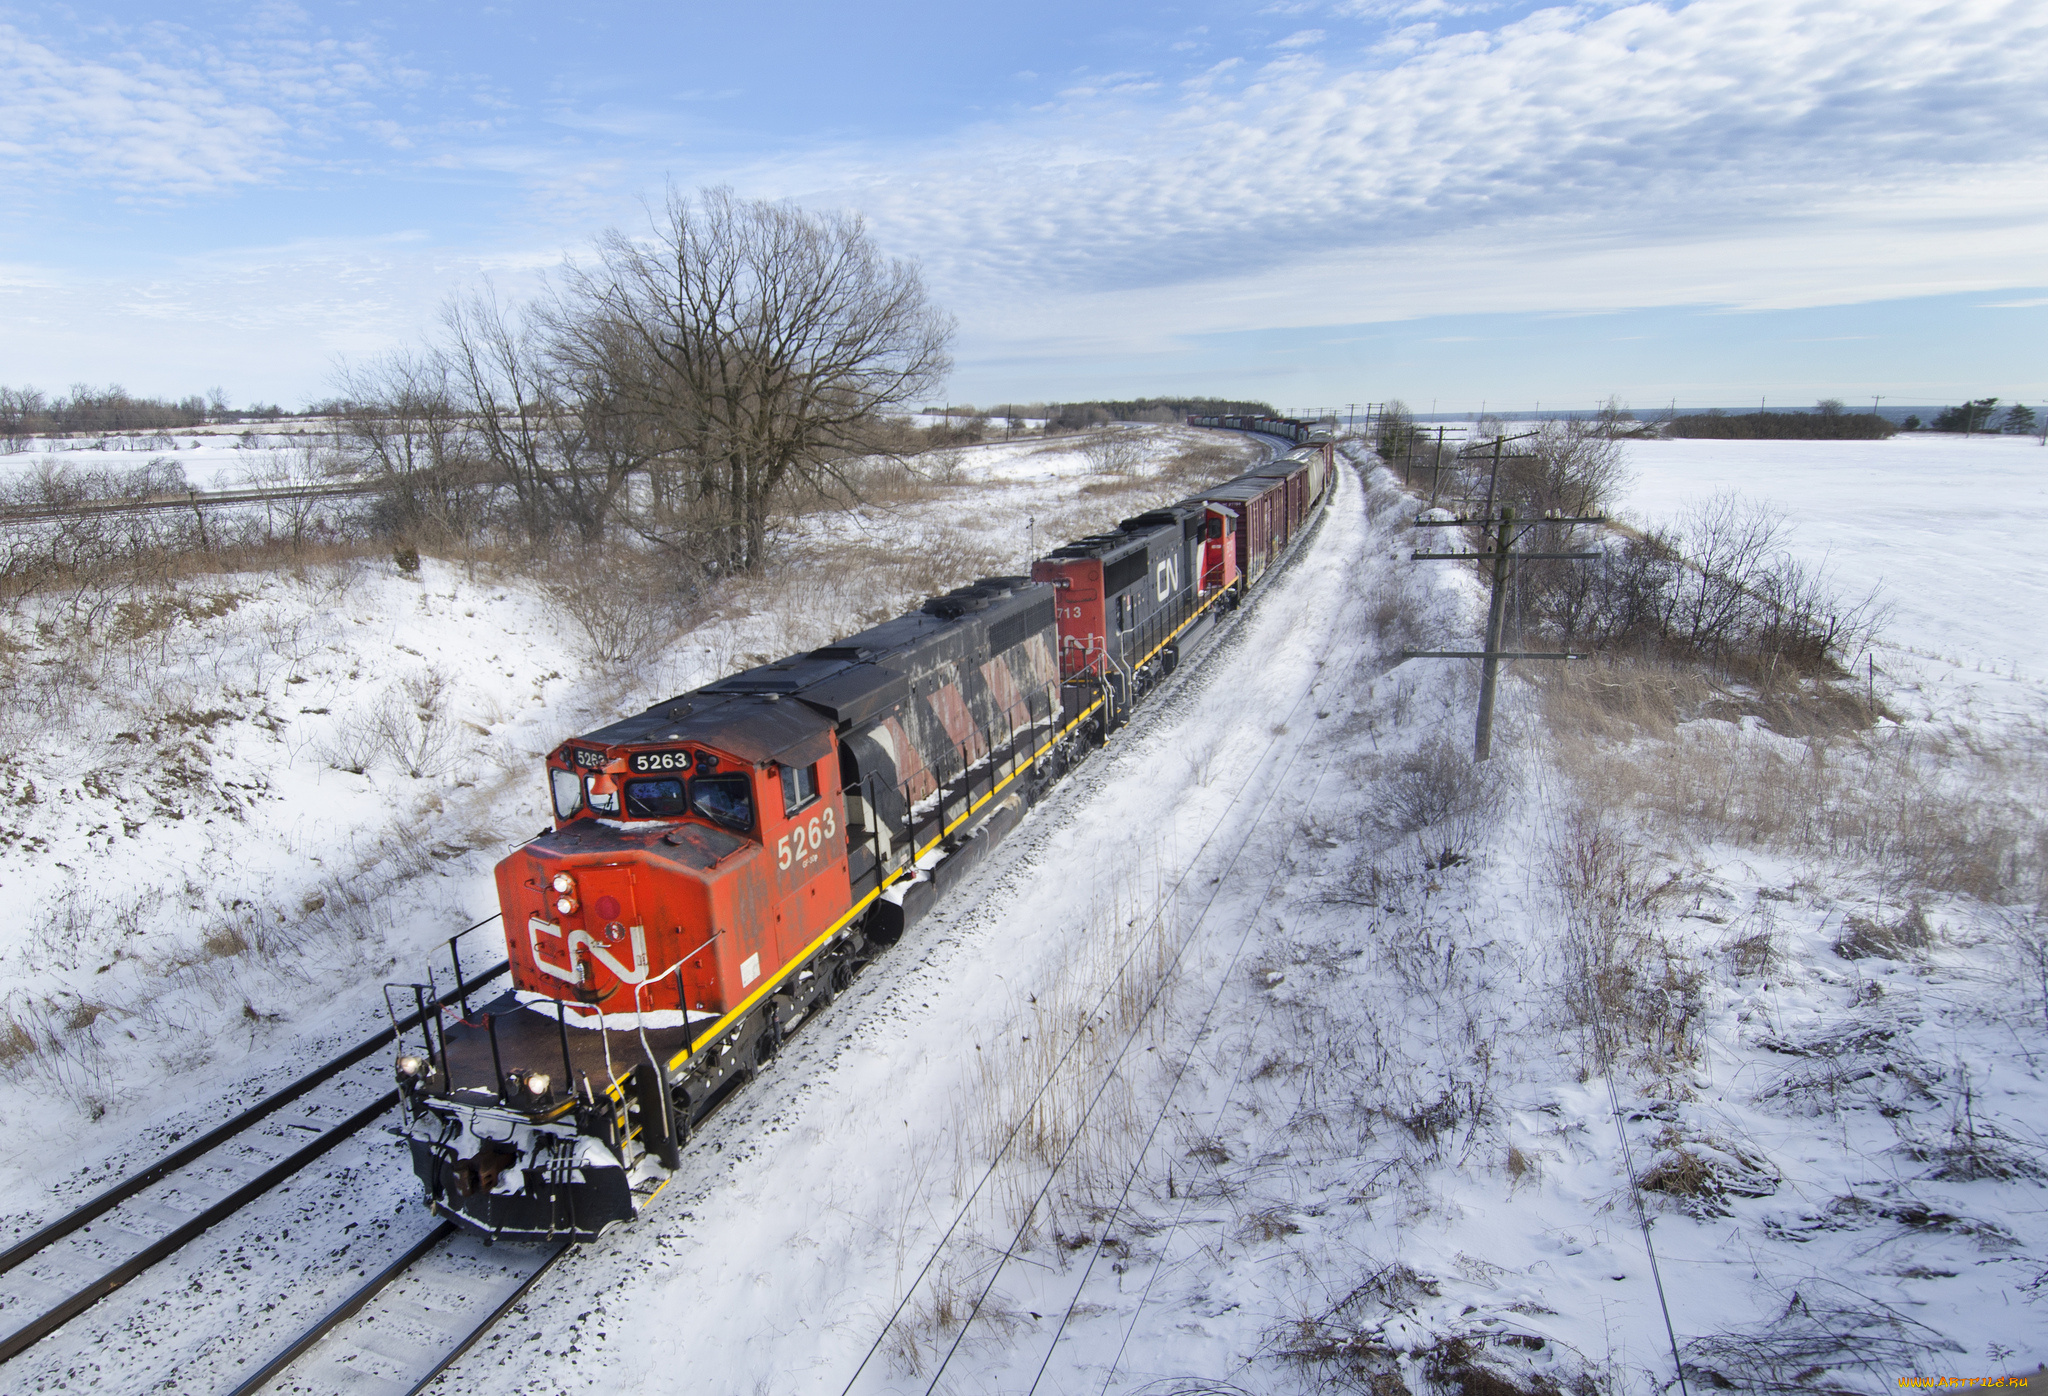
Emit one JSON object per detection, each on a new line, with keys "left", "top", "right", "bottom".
{"left": 548, "top": 188, "right": 952, "bottom": 571}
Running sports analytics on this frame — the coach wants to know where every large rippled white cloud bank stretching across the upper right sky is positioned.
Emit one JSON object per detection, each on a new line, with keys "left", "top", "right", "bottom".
{"left": 770, "top": 0, "right": 2048, "bottom": 356}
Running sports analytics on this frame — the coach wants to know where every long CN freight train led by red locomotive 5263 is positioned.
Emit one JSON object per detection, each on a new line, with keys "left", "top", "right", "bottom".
{"left": 387, "top": 418, "right": 1335, "bottom": 1242}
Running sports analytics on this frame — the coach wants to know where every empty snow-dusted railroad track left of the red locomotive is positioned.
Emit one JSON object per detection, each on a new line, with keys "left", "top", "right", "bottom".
{"left": 0, "top": 917, "right": 506, "bottom": 1363}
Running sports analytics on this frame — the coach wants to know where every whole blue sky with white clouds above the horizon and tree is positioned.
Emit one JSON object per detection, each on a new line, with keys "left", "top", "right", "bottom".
{"left": 0, "top": 0, "right": 2048, "bottom": 409}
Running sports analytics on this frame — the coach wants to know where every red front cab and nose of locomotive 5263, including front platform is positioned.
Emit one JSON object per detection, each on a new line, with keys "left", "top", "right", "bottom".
{"left": 395, "top": 696, "right": 852, "bottom": 1236}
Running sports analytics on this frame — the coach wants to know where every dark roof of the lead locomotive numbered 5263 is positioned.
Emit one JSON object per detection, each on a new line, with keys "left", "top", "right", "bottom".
{"left": 588, "top": 577, "right": 1053, "bottom": 764}
